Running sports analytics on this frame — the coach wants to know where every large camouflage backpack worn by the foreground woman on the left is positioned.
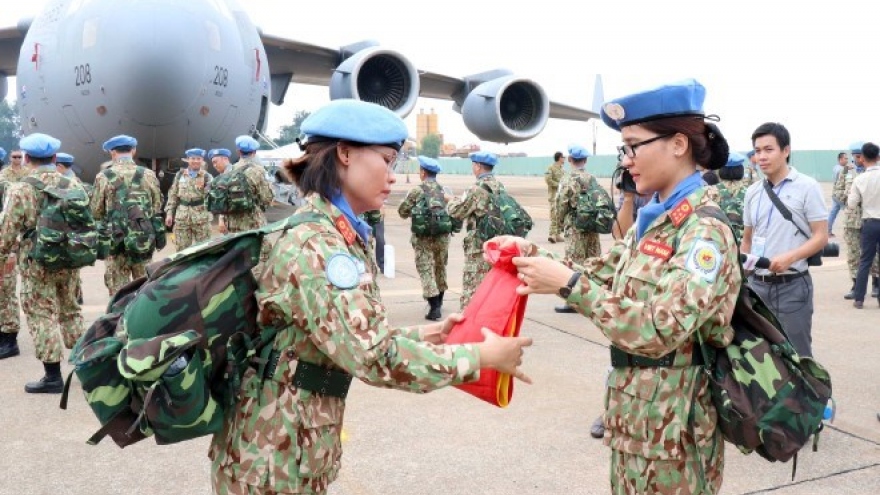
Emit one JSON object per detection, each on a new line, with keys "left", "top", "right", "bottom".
{"left": 61, "top": 214, "right": 319, "bottom": 447}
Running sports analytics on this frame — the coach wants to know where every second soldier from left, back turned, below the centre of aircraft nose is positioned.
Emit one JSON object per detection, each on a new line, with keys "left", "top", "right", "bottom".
{"left": 91, "top": 134, "right": 162, "bottom": 297}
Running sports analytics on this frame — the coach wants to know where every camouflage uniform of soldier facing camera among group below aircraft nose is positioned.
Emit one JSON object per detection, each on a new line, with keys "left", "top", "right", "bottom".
{"left": 165, "top": 169, "right": 211, "bottom": 251}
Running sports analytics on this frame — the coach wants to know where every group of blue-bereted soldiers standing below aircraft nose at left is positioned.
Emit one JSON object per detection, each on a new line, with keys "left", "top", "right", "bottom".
{"left": 0, "top": 133, "right": 274, "bottom": 393}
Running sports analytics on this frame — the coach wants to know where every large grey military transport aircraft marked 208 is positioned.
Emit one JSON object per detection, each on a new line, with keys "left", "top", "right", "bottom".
{"left": 0, "top": 0, "right": 597, "bottom": 185}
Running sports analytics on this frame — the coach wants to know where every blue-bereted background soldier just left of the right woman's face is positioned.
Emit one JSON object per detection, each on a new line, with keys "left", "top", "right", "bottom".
{"left": 554, "top": 145, "right": 602, "bottom": 313}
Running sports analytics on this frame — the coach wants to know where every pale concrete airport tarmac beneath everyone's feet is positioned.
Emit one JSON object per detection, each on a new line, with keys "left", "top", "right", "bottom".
{"left": 0, "top": 175, "right": 880, "bottom": 495}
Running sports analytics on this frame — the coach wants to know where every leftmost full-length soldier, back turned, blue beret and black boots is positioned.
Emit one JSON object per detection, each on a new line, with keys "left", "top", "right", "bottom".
{"left": 0, "top": 133, "right": 85, "bottom": 394}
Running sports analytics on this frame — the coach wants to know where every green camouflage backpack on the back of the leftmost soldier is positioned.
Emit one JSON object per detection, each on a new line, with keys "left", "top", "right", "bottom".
{"left": 22, "top": 176, "right": 98, "bottom": 270}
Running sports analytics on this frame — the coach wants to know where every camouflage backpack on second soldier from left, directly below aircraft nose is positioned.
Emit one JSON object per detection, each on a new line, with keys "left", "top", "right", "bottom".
{"left": 102, "top": 166, "right": 165, "bottom": 262}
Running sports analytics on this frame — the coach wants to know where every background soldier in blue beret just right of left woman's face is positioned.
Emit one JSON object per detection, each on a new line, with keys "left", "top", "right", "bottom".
{"left": 397, "top": 156, "right": 452, "bottom": 321}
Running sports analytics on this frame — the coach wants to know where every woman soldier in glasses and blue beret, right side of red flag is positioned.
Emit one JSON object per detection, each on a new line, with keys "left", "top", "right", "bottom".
{"left": 506, "top": 80, "right": 740, "bottom": 495}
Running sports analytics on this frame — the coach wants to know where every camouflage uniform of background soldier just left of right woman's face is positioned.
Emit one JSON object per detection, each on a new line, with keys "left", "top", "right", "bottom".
{"left": 556, "top": 168, "right": 602, "bottom": 264}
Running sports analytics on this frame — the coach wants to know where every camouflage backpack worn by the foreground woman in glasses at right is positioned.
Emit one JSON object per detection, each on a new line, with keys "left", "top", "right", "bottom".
{"left": 696, "top": 206, "right": 831, "bottom": 470}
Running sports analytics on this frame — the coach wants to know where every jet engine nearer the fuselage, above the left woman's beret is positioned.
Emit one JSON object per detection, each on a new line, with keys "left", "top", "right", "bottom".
{"left": 330, "top": 46, "right": 419, "bottom": 118}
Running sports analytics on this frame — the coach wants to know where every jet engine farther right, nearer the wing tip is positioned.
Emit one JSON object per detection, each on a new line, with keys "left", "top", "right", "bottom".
{"left": 461, "top": 75, "right": 550, "bottom": 143}
